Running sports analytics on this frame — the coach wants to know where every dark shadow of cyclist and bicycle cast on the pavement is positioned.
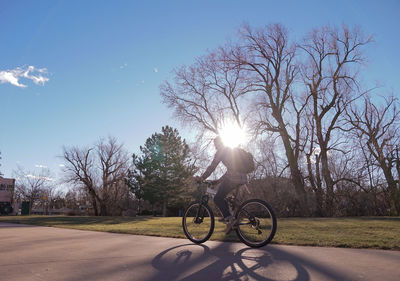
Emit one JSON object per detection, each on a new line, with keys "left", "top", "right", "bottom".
{"left": 151, "top": 243, "right": 310, "bottom": 281}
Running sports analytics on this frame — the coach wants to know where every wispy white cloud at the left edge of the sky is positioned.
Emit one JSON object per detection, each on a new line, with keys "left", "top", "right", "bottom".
{"left": 0, "top": 65, "right": 50, "bottom": 88}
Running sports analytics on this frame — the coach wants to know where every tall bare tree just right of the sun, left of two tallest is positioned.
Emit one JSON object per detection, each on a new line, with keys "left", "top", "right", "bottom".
{"left": 230, "top": 24, "right": 308, "bottom": 214}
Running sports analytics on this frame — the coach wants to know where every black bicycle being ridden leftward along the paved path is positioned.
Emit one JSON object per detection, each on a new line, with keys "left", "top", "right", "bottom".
{"left": 182, "top": 181, "right": 277, "bottom": 248}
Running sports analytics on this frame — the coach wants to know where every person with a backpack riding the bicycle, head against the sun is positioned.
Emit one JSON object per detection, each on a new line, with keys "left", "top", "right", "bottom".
{"left": 195, "top": 136, "right": 254, "bottom": 233}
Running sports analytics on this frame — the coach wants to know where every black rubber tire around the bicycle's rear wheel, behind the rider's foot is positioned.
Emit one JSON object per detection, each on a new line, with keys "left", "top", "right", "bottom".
{"left": 235, "top": 199, "right": 277, "bottom": 248}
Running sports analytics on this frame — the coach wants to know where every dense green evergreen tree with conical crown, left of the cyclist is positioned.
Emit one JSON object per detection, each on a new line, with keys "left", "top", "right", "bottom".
{"left": 127, "top": 126, "right": 195, "bottom": 216}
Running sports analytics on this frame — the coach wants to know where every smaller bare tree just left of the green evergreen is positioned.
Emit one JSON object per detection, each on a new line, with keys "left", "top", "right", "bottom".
{"left": 63, "top": 137, "right": 129, "bottom": 216}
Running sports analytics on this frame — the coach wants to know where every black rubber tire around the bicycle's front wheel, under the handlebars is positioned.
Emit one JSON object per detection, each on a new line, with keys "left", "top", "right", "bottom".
{"left": 182, "top": 202, "right": 215, "bottom": 244}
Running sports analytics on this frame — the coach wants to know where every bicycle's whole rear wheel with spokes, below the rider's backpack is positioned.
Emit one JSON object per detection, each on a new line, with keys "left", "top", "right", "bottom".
{"left": 236, "top": 199, "right": 277, "bottom": 248}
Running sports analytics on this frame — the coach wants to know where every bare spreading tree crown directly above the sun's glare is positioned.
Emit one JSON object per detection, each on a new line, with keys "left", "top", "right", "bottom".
{"left": 160, "top": 46, "right": 251, "bottom": 134}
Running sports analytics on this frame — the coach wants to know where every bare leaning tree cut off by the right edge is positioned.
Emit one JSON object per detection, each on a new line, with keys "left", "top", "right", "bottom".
{"left": 347, "top": 97, "right": 400, "bottom": 215}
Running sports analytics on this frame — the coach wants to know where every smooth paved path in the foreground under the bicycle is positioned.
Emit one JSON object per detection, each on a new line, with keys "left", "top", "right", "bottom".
{"left": 0, "top": 223, "right": 400, "bottom": 281}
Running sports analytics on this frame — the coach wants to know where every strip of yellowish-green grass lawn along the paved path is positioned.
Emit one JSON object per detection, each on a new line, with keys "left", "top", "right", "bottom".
{"left": 0, "top": 216, "right": 400, "bottom": 250}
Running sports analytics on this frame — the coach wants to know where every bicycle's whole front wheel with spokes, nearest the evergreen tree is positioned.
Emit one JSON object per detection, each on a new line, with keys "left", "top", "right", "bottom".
{"left": 182, "top": 202, "right": 215, "bottom": 244}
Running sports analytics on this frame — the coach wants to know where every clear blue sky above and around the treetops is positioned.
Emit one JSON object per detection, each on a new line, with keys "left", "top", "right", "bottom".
{"left": 0, "top": 0, "right": 400, "bottom": 182}
